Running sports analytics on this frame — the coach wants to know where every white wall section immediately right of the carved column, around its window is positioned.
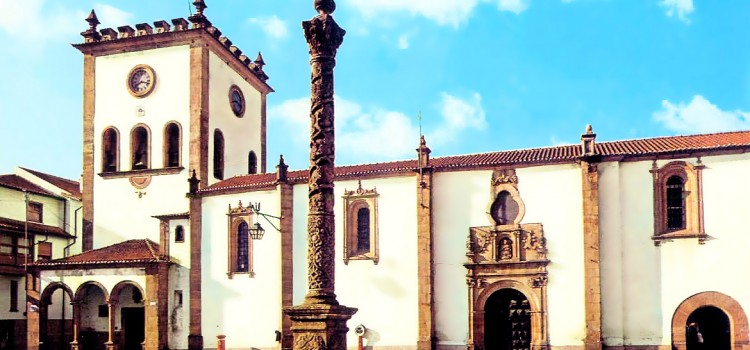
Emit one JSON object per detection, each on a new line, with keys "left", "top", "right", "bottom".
{"left": 336, "top": 176, "right": 419, "bottom": 348}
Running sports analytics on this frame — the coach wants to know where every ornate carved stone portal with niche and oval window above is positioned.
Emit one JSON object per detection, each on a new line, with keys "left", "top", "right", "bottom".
{"left": 464, "top": 169, "right": 549, "bottom": 350}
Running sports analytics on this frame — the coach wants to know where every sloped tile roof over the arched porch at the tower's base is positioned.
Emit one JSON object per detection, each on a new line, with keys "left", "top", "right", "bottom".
{"left": 30, "top": 239, "right": 163, "bottom": 267}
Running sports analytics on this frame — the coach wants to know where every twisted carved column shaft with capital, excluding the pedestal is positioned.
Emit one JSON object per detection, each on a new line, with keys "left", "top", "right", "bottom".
{"left": 302, "top": 0, "right": 346, "bottom": 305}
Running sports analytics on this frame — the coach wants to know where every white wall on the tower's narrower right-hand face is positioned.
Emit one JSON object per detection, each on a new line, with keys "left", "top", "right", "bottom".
{"left": 208, "top": 52, "right": 261, "bottom": 184}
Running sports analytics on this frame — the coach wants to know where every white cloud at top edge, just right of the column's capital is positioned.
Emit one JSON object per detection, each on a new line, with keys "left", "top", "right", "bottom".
{"left": 345, "top": 0, "right": 484, "bottom": 27}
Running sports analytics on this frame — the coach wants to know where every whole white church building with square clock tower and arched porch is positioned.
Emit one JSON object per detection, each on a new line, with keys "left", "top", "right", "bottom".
{"left": 20, "top": 0, "right": 750, "bottom": 350}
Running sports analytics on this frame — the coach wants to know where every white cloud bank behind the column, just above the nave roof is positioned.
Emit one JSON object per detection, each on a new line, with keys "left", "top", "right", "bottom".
{"left": 268, "top": 93, "right": 486, "bottom": 164}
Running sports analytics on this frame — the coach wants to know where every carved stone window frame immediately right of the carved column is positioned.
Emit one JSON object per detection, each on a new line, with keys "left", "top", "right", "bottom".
{"left": 343, "top": 181, "right": 380, "bottom": 265}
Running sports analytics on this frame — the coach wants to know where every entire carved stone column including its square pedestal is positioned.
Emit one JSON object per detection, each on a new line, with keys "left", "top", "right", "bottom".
{"left": 285, "top": 0, "right": 357, "bottom": 350}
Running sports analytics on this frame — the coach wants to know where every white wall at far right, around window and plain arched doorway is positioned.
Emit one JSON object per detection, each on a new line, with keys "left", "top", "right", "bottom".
{"left": 599, "top": 154, "right": 750, "bottom": 345}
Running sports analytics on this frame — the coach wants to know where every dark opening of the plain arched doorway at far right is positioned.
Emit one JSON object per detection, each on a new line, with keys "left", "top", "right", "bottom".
{"left": 685, "top": 306, "right": 732, "bottom": 350}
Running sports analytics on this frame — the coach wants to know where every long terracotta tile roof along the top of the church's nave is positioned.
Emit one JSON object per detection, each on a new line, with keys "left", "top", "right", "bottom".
{"left": 200, "top": 131, "right": 750, "bottom": 194}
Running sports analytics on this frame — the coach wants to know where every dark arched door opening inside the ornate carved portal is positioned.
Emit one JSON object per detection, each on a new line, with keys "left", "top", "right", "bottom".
{"left": 484, "top": 288, "right": 531, "bottom": 350}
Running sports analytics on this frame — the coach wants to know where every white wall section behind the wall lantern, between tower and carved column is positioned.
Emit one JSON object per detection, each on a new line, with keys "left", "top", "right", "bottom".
{"left": 201, "top": 189, "right": 281, "bottom": 348}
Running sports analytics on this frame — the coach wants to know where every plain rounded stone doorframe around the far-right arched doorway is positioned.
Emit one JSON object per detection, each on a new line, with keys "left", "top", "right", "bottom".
{"left": 672, "top": 292, "right": 750, "bottom": 350}
